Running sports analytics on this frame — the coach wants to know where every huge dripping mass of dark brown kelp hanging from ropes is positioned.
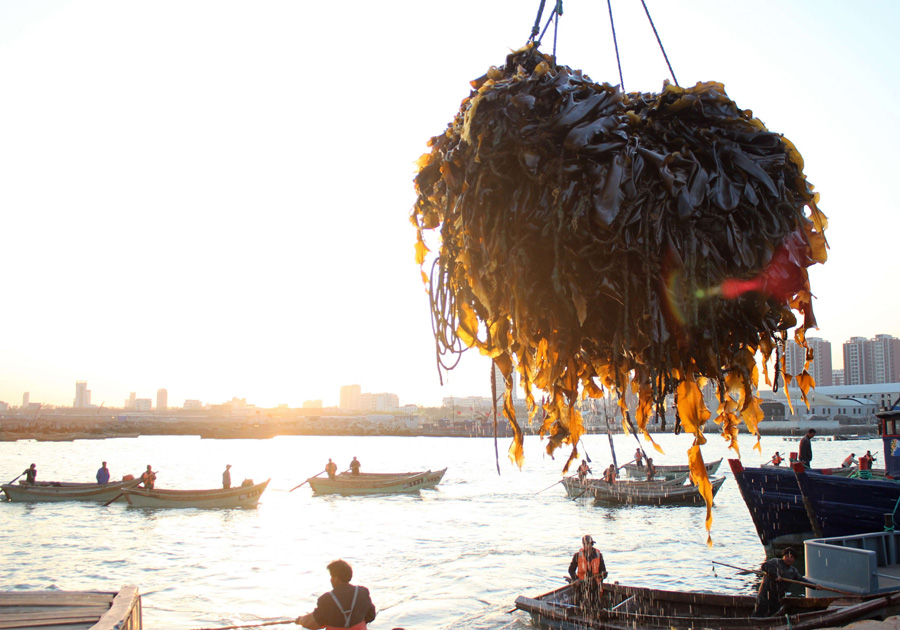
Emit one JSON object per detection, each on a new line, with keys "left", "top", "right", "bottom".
{"left": 411, "top": 45, "right": 827, "bottom": 528}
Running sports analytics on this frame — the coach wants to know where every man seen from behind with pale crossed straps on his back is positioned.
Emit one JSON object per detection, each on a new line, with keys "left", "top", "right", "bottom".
{"left": 294, "top": 560, "right": 375, "bottom": 630}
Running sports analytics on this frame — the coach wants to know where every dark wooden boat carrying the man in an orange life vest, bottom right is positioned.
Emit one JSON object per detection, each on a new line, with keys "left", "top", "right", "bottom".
{"left": 516, "top": 584, "right": 900, "bottom": 630}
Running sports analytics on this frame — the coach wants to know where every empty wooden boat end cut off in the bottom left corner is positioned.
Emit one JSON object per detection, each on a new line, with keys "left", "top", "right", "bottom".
{"left": 0, "top": 586, "right": 143, "bottom": 630}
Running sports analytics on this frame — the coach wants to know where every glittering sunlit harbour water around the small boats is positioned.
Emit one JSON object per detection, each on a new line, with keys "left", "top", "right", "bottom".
{"left": 0, "top": 434, "right": 882, "bottom": 630}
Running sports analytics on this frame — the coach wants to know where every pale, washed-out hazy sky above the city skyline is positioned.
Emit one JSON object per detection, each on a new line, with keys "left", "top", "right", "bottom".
{"left": 0, "top": 0, "right": 900, "bottom": 406}
